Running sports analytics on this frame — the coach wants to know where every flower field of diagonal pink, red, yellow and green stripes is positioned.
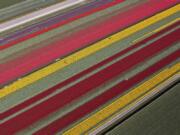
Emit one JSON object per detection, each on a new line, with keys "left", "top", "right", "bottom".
{"left": 0, "top": 0, "right": 180, "bottom": 135}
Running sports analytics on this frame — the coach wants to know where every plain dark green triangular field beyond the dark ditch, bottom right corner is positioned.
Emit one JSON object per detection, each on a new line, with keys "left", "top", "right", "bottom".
{"left": 107, "top": 83, "right": 180, "bottom": 135}
